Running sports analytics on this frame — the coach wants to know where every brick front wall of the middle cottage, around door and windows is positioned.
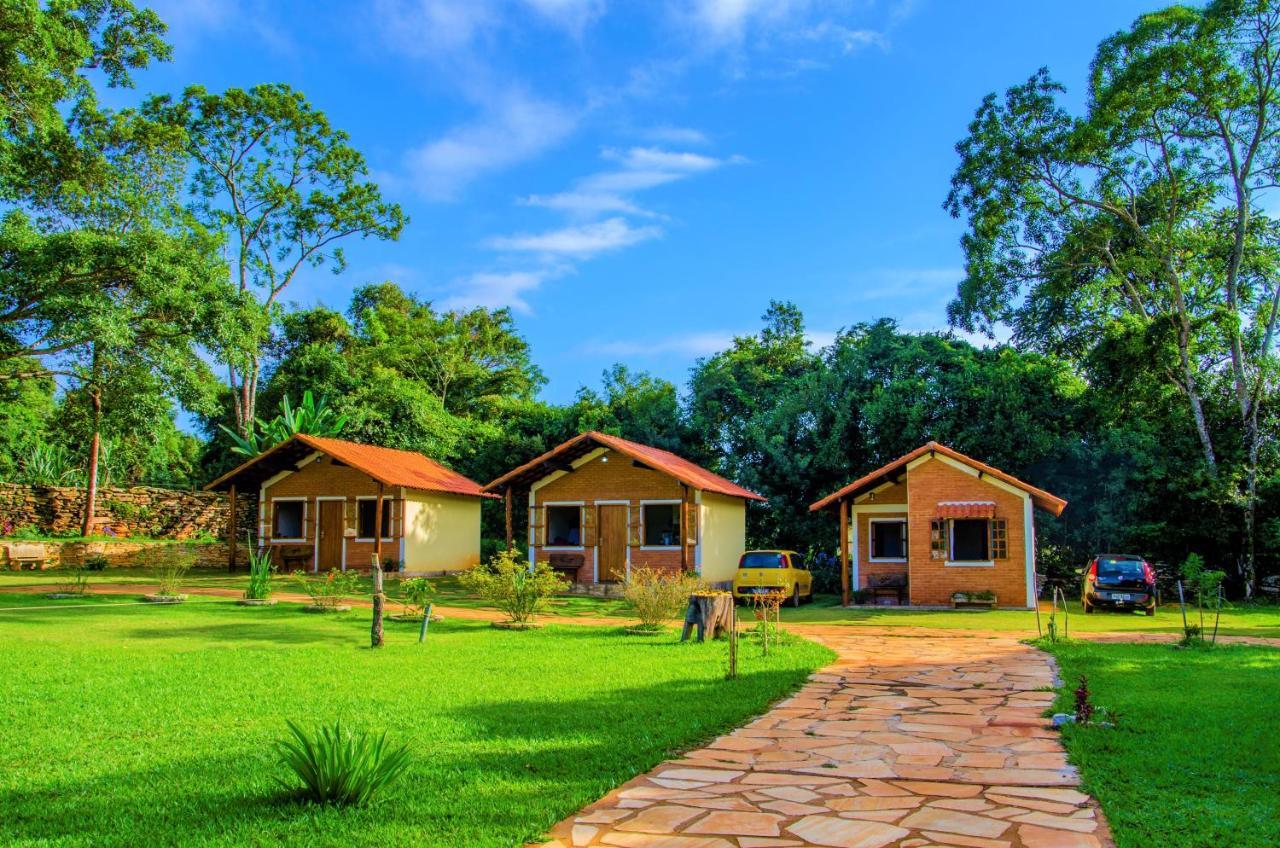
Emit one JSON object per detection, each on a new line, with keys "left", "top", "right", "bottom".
{"left": 532, "top": 451, "right": 696, "bottom": 583}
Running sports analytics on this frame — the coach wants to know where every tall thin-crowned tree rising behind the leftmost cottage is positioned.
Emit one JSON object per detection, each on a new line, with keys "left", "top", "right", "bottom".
{"left": 145, "top": 85, "right": 406, "bottom": 436}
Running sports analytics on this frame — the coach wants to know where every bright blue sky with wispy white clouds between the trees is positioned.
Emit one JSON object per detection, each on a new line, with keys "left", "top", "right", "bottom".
{"left": 116, "top": 0, "right": 1155, "bottom": 401}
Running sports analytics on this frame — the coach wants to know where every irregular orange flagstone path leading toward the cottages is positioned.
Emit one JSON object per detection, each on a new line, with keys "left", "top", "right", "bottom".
{"left": 545, "top": 626, "right": 1112, "bottom": 848}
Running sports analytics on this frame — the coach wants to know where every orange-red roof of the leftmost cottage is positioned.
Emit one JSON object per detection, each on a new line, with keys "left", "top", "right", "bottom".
{"left": 205, "top": 433, "right": 493, "bottom": 497}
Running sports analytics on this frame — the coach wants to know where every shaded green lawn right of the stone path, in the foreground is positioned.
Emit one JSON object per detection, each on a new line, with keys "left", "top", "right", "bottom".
{"left": 1050, "top": 642, "right": 1280, "bottom": 848}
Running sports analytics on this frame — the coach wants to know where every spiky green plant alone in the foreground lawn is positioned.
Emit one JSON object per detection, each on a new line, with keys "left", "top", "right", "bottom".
{"left": 278, "top": 721, "right": 410, "bottom": 807}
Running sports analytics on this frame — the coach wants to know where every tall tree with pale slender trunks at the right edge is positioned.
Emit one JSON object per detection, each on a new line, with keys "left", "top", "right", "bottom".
{"left": 946, "top": 0, "right": 1280, "bottom": 589}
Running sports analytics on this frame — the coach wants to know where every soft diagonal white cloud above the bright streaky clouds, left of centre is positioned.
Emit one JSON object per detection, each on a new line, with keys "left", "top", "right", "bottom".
{"left": 404, "top": 91, "right": 577, "bottom": 200}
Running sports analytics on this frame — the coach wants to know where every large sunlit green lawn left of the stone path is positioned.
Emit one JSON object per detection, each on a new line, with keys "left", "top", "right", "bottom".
{"left": 0, "top": 593, "right": 832, "bottom": 848}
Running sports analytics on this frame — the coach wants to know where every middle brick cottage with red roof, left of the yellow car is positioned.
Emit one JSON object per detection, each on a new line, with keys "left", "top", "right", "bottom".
{"left": 485, "top": 432, "right": 764, "bottom": 584}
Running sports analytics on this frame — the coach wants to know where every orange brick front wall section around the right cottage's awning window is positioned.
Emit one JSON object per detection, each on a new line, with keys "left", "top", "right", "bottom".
{"left": 906, "top": 459, "right": 1027, "bottom": 607}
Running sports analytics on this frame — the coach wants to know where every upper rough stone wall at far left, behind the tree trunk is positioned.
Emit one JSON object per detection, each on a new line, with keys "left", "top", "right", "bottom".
{"left": 0, "top": 483, "right": 257, "bottom": 541}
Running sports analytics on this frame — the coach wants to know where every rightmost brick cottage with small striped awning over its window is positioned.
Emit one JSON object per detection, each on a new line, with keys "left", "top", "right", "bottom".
{"left": 809, "top": 442, "right": 1066, "bottom": 608}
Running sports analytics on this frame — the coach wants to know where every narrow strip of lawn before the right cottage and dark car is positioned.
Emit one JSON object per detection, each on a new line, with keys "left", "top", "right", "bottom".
{"left": 782, "top": 594, "right": 1280, "bottom": 638}
